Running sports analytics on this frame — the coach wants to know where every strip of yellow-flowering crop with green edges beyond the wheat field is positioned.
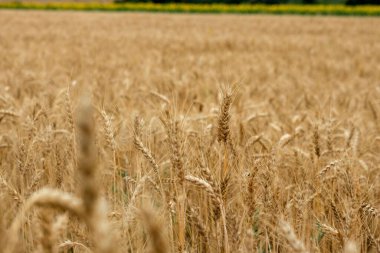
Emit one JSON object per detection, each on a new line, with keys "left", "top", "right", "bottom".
{"left": 0, "top": 0, "right": 380, "bottom": 16}
